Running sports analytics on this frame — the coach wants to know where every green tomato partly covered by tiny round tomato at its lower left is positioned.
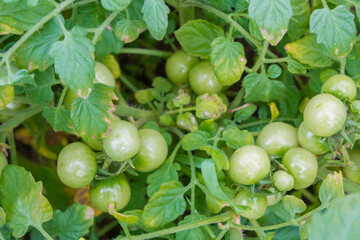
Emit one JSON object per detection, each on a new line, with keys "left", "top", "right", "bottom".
{"left": 282, "top": 148, "right": 318, "bottom": 189}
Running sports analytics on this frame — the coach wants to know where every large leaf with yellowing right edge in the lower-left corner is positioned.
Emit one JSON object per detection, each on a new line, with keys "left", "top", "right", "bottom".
{"left": 0, "top": 165, "right": 53, "bottom": 238}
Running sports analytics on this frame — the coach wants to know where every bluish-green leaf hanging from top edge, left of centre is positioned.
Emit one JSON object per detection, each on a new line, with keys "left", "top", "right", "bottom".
{"left": 141, "top": 0, "right": 170, "bottom": 40}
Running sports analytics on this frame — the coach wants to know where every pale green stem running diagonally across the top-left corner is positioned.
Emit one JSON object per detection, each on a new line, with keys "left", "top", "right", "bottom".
{"left": 0, "top": 0, "right": 75, "bottom": 66}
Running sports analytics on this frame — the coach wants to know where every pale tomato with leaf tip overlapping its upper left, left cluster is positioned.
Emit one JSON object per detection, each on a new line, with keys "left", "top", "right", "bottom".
{"left": 103, "top": 120, "right": 141, "bottom": 161}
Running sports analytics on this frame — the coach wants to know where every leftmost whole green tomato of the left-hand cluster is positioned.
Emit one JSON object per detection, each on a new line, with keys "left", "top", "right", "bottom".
{"left": 57, "top": 142, "right": 97, "bottom": 188}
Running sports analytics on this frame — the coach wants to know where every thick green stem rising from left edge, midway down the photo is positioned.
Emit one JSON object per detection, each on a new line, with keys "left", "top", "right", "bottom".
{"left": 0, "top": 105, "right": 42, "bottom": 133}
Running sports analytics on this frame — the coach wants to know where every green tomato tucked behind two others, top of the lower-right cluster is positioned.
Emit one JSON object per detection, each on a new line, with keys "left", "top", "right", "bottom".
{"left": 256, "top": 122, "right": 299, "bottom": 157}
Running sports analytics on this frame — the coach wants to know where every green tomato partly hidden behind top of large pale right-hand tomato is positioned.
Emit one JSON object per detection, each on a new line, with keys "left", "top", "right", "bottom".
{"left": 321, "top": 74, "right": 357, "bottom": 101}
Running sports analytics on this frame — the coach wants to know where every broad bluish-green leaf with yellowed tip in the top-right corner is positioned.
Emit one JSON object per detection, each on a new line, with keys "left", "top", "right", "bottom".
{"left": 310, "top": 5, "right": 356, "bottom": 58}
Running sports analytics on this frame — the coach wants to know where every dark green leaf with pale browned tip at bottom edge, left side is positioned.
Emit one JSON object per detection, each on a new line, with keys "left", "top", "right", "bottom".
{"left": 44, "top": 203, "right": 94, "bottom": 240}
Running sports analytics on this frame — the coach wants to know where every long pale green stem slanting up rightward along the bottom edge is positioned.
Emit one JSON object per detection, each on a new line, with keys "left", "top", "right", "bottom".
{"left": 115, "top": 212, "right": 234, "bottom": 240}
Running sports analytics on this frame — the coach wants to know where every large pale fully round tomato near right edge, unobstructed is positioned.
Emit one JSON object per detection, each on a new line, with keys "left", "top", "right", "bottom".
{"left": 304, "top": 93, "right": 346, "bottom": 137}
